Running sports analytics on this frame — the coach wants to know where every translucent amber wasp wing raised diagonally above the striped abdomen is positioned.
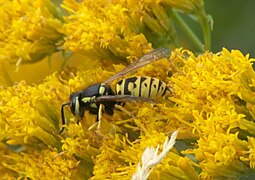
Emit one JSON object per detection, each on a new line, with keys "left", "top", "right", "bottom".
{"left": 104, "top": 48, "right": 170, "bottom": 84}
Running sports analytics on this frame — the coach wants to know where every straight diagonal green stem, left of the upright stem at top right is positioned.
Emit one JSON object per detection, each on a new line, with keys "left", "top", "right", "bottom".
{"left": 173, "top": 10, "right": 204, "bottom": 52}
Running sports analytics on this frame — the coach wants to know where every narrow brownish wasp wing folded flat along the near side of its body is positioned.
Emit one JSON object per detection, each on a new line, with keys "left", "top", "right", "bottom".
{"left": 94, "top": 95, "right": 156, "bottom": 104}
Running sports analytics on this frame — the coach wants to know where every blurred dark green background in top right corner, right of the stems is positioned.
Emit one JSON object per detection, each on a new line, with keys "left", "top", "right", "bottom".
{"left": 205, "top": 0, "right": 255, "bottom": 57}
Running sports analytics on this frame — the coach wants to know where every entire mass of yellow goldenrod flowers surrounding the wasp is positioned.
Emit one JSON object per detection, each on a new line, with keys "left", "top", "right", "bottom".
{"left": 0, "top": 0, "right": 255, "bottom": 179}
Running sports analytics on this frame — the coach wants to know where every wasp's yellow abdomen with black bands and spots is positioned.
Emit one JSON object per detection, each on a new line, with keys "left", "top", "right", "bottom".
{"left": 116, "top": 76, "right": 170, "bottom": 99}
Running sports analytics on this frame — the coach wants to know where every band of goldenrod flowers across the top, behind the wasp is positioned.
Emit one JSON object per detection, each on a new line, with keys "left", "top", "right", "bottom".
{"left": 0, "top": 0, "right": 205, "bottom": 65}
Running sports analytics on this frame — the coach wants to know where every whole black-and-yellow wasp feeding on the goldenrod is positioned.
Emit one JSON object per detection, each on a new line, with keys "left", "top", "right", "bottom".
{"left": 59, "top": 48, "right": 171, "bottom": 134}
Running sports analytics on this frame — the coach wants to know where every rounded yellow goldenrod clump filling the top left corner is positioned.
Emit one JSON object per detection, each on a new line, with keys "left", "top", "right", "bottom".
{"left": 0, "top": 0, "right": 62, "bottom": 64}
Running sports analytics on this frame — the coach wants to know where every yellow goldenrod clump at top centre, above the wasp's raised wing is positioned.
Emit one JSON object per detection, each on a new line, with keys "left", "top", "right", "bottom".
{"left": 63, "top": 0, "right": 151, "bottom": 57}
